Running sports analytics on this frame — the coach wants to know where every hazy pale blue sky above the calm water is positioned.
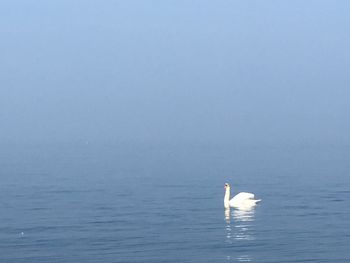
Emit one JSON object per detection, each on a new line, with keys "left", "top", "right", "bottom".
{"left": 0, "top": 0, "right": 350, "bottom": 143}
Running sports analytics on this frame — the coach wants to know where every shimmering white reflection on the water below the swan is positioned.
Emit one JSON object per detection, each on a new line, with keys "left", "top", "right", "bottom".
{"left": 225, "top": 208, "right": 255, "bottom": 262}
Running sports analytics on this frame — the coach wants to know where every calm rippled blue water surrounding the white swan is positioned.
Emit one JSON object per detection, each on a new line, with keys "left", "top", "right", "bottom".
{"left": 0, "top": 143, "right": 350, "bottom": 263}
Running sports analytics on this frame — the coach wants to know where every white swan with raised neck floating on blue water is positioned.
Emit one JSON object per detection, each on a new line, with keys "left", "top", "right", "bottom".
{"left": 224, "top": 183, "right": 261, "bottom": 209}
